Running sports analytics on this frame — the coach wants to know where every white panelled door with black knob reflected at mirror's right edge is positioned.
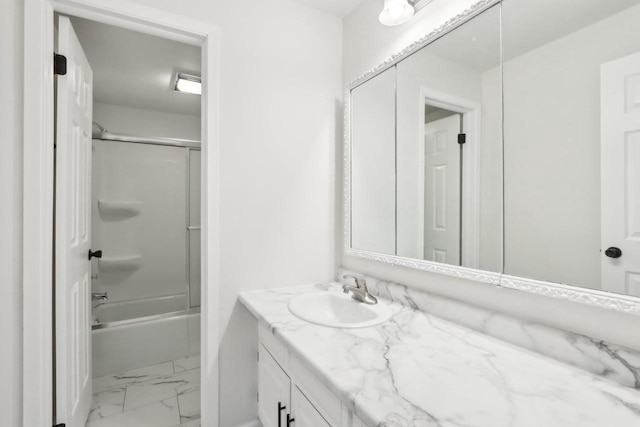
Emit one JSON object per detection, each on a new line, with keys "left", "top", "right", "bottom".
{"left": 600, "top": 54, "right": 640, "bottom": 296}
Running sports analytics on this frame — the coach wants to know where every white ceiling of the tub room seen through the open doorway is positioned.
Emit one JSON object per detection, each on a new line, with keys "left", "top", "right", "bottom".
{"left": 71, "top": 17, "right": 201, "bottom": 116}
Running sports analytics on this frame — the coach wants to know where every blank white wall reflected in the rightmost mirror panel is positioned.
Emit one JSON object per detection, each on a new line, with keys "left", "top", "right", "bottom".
{"left": 504, "top": 2, "right": 640, "bottom": 289}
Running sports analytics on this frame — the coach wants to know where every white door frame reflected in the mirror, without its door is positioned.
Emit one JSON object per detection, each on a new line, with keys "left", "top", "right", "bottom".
{"left": 416, "top": 86, "right": 482, "bottom": 268}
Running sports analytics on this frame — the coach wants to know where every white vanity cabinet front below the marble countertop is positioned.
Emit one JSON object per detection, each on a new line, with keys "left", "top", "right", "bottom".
{"left": 258, "top": 324, "right": 365, "bottom": 427}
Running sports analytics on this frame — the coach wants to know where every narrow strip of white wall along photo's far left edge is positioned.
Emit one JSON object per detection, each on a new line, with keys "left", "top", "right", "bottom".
{"left": 0, "top": 0, "right": 23, "bottom": 426}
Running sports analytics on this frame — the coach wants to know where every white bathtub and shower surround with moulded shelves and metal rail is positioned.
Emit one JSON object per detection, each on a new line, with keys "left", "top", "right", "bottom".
{"left": 91, "top": 125, "right": 200, "bottom": 376}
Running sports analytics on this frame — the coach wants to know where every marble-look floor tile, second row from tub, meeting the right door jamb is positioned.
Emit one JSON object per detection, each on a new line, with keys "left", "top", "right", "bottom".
{"left": 124, "top": 369, "right": 200, "bottom": 411}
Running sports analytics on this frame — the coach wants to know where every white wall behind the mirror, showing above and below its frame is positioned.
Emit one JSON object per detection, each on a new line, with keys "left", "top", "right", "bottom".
{"left": 337, "top": 0, "right": 640, "bottom": 349}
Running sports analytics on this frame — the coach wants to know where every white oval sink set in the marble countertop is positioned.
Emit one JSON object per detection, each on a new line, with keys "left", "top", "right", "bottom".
{"left": 289, "top": 292, "right": 393, "bottom": 328}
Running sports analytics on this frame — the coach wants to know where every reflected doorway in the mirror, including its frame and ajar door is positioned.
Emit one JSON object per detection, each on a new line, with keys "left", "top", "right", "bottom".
{"left": 416, "top": 87, "right": 482, "bottom": 268}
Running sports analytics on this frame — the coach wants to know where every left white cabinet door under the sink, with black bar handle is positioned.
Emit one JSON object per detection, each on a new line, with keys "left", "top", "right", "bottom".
{"left": 258, "top": 345, "right": 292, "bottom": 427}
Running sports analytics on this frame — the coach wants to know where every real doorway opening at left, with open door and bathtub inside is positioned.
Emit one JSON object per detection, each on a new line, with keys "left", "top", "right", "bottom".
{"left": 54, "top": 14, "right": 202, "bottom": 427}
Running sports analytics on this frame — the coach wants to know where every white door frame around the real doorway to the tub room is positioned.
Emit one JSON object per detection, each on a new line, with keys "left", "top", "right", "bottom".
{"left": 22, "top": 0, "right": 220, "bottom": 427}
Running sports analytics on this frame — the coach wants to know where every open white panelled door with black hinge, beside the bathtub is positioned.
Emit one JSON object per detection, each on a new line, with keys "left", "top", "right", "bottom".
{"left": 55, "top": 16, "right": 93, "bottom": 427}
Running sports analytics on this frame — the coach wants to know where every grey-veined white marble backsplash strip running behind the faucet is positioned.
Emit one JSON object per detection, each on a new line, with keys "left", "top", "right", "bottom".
{"left": 338, "top": 268, "right": 640, "bottom": 389}
